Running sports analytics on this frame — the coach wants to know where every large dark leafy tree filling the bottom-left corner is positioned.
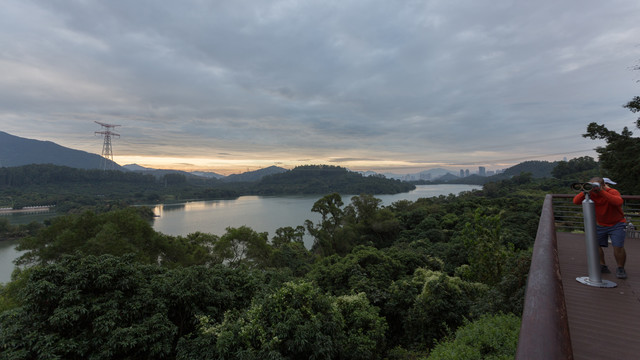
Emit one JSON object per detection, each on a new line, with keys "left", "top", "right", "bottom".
{"left": 0, "top": 255, "right": 176, "bottom": 359}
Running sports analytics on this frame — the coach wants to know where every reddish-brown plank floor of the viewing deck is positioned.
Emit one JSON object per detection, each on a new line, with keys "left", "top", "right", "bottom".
{"left": 557, "top": 233, "right": 640, "bottom": 360}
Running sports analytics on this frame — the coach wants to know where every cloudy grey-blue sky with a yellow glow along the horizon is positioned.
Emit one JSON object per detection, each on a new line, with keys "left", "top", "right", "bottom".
{"left": 0, "top": 0, "right": 640, "bottom": 175}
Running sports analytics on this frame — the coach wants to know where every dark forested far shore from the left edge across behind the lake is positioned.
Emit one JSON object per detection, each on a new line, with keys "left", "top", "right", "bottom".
{"left": 0, "top": 165, "right": 415, "bottom": 214}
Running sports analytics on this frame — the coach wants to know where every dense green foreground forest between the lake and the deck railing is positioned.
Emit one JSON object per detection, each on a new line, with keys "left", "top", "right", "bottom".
{"left": 0, "top": 105, "right": 640, "bottom": 360}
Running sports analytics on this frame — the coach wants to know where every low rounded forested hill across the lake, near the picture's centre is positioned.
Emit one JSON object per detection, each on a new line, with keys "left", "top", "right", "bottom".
{"left": 253, "top": 165, "right": 415, "bottom": 195}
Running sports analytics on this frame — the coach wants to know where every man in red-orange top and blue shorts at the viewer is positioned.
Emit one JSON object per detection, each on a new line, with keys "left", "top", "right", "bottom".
{"left": 573, "top": 177, "right": 627, "bottom": 279}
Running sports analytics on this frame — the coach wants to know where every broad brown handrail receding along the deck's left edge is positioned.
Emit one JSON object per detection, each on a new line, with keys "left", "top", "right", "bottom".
{"left": 516, "top": 194, "right": 573, "bottom": 360}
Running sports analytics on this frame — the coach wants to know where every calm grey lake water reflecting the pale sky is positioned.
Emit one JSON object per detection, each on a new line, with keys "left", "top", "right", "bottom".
{"left": 0, "top": 185, "right": 481, "bottom": 283}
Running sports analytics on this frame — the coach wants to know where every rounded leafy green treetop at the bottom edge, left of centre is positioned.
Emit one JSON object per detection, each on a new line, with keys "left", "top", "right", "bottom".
{"left": 178, "top": 282, "right": 385, "bottom": 360}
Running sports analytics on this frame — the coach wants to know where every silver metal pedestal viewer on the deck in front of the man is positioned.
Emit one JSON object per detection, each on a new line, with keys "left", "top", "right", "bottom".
{"left": 571, "top": 182, "right": 617, "bottom": 288}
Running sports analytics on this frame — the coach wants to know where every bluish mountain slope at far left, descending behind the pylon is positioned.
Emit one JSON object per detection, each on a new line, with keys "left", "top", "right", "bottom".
{"left": 0, "top": 131, "right": 123, "bottom": 170}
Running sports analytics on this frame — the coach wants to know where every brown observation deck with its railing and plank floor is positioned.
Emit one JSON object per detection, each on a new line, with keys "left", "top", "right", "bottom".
{"left": 516, "top": 194, "right": 640, "bottom": 360}
